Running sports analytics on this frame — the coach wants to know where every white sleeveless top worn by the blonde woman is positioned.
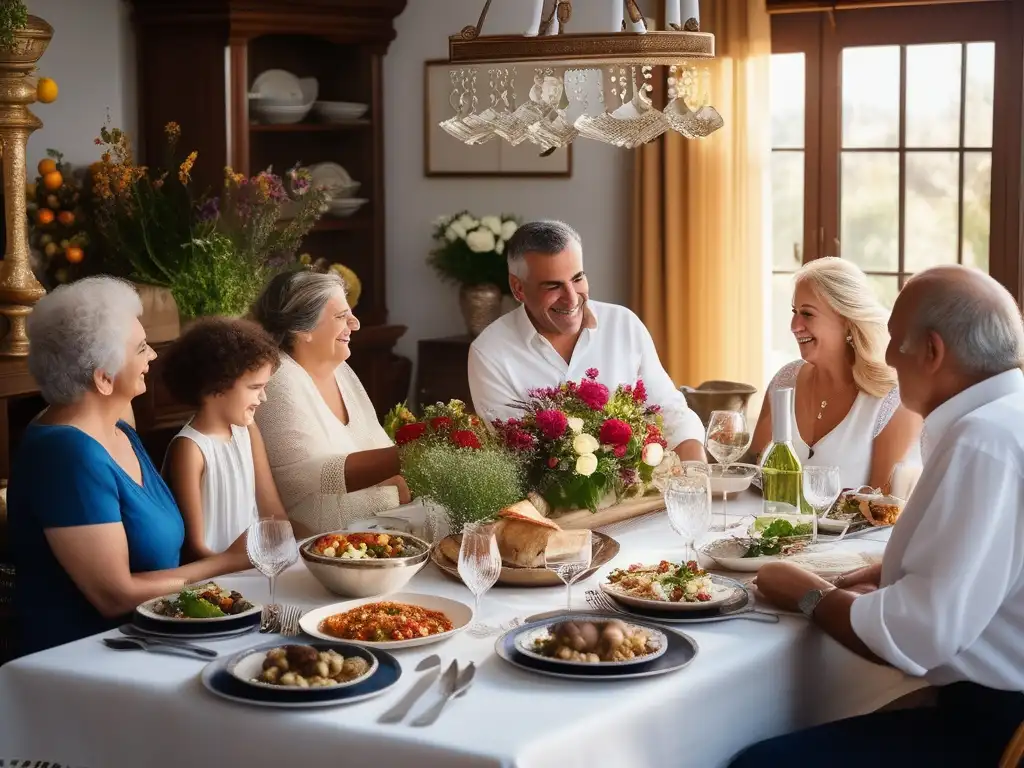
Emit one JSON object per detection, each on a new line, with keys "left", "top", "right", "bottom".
{"left": 767, "top": 360, "right": 921, "bottom": 488}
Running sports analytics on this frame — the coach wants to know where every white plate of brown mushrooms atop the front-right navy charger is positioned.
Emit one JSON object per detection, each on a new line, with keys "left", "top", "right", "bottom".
{"left": 515, "top": 620, "right": 669, "bottom": 667}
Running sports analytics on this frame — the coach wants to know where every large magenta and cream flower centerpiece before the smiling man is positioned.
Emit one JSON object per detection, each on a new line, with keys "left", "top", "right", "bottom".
{"left": 494, "top": 369, "right": 668, "bottom": 512}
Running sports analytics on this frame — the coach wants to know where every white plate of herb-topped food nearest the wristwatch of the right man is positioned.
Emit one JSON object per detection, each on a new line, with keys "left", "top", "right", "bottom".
{"left": 599, "top": 560, "right": 736, "bottom": 612}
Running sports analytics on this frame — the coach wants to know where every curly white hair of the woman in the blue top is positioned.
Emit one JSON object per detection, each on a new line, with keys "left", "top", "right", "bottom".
{"left": 27, "top": 275, "right": 142, "bottom": 406}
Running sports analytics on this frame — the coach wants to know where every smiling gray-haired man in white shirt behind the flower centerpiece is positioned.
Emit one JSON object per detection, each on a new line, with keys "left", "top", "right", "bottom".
{"left": 469, "top": 221, "right": 706, "bottom": 461}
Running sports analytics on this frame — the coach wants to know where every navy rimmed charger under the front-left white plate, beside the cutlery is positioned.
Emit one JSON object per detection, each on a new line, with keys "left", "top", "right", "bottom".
{"left": 200, "top": 640, "right": 401, "bottom": 710}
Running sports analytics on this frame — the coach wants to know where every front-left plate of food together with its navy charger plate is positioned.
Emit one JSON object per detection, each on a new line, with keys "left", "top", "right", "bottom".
{"left": 201, "top": 641, "right": 401, "bottom": 709}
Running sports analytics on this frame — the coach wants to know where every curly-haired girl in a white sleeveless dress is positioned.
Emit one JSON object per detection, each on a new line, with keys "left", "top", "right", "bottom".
{"left": 164, "top": 317, "right": 285, "bottom": 558}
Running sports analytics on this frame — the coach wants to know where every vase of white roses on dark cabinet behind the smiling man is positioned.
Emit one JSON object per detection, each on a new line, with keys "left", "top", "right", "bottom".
{"left": 428, "top": 211, "right": 519, "bottom": 336}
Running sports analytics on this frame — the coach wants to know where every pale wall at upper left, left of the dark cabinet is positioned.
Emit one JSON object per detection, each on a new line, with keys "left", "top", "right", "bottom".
{"left": 27, "top": 0, "right": 138, "bottom": 177}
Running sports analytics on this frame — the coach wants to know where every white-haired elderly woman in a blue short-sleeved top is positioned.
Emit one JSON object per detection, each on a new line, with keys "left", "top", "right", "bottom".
{"left": 8, "top": 278, "right": 249, "bottom": 653}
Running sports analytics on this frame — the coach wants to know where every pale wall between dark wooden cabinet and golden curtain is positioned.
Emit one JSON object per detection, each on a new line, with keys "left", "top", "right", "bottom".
{"left": 384, "top": 0, "right": 633, "bottom": 357}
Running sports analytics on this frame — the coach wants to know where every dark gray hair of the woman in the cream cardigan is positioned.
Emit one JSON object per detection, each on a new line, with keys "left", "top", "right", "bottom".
{"left": 252, "top": 270, "right": 345, "bottom": 352}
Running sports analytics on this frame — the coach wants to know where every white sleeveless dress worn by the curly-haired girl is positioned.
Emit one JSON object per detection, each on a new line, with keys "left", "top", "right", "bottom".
{"left": 166, "top": 422, "right": 258, "bottom": 552}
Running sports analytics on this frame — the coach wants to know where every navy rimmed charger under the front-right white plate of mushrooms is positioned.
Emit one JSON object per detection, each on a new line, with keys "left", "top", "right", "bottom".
{"left": 495, "top": 613, "right": 698, "bottom": 682}
